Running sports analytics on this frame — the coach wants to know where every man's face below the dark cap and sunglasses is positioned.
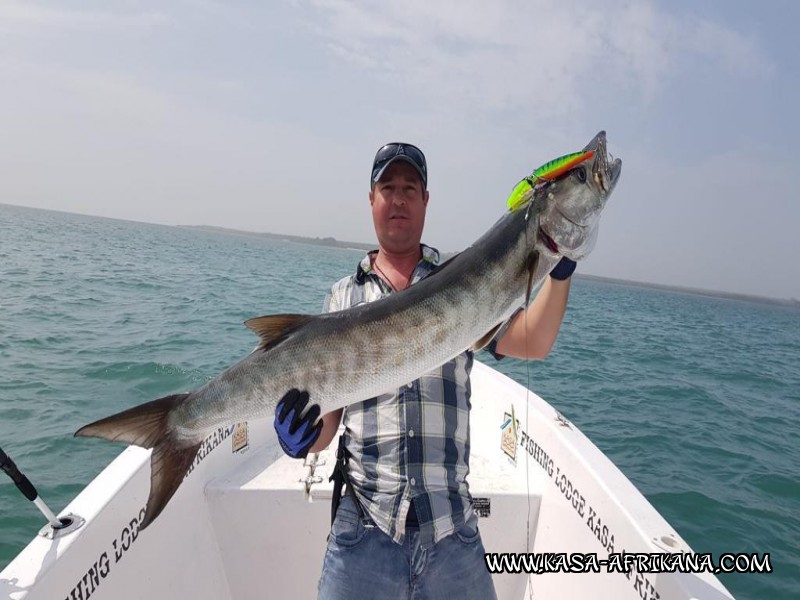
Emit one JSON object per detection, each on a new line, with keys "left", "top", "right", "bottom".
{"left": 369, "top": 161, "right": 428, "bottom": 253}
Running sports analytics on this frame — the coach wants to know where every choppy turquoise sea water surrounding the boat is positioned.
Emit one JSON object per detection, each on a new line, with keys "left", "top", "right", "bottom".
{"left": 0, "top": 205, "right": 800, "bottom": 599}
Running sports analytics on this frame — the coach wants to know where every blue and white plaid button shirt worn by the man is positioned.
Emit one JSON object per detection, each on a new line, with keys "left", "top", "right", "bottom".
{"left": 324, "top": 245, "right": 474, "bottom": 548}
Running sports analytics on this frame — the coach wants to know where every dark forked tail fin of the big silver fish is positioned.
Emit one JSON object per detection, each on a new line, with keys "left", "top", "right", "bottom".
{"left": 75, "top": 394, "right": 203, "bottom": 529}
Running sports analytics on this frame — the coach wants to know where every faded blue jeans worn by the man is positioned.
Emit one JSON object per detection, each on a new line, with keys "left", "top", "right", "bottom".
{"left": 317, "top": 496, "right": 497, "bottom": 600}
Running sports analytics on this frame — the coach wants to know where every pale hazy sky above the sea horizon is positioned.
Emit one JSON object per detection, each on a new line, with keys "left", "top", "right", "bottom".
{"left": 0, "top": 0, "right": 800, "bottom": 299}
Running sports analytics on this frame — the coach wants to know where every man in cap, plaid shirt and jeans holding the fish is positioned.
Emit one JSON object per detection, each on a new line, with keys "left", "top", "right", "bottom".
{"left": 275, "top": 143, "right": 575, "bottom": 600}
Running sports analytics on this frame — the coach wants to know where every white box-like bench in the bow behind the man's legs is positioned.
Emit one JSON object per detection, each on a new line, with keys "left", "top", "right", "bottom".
{"left": 206, "top": 432, "right": 544, "bottom": 599}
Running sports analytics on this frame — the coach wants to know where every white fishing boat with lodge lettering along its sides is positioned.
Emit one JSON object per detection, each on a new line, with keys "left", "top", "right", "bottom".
{"left": 0, "top": 361, "right": 732, "bottom": 600}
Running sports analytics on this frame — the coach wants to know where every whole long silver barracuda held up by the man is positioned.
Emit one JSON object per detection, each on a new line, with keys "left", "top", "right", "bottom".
{"left": 75, "top": 132, "right": 621, "bottom": 529}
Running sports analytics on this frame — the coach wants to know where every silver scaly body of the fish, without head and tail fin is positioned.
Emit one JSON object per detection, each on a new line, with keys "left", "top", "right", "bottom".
{"left": 174, "top": 199, "right": 536, "bottom": 440}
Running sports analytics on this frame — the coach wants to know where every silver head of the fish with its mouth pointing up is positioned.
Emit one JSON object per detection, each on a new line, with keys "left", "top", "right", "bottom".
{"left": 537, "top": 131, "right": 622, "bottom": 260}
